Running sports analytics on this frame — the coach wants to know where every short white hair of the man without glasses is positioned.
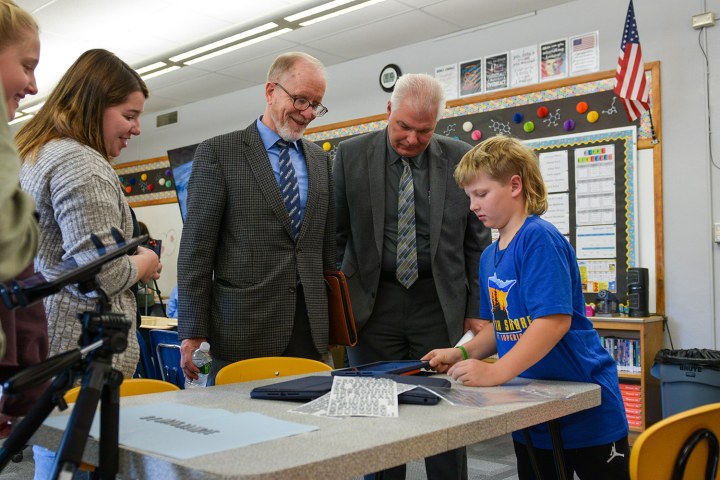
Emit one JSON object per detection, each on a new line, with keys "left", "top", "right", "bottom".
{"left": 390, "top": 73, "right": 446, "bottom": 120}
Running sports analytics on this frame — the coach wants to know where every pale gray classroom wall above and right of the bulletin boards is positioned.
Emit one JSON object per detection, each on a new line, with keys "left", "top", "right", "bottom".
{"left": 118, "top": 0, "right": 720, "bottom": 348}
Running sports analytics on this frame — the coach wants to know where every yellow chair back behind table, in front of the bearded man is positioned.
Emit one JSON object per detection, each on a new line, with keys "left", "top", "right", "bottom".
{"left": 215, "top": 357, "right": 332, "bottom": 385}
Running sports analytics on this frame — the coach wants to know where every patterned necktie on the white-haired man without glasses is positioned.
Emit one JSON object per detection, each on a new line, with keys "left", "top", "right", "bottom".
{"left": 395, "top": 157, "right": 418, "bottom": 288}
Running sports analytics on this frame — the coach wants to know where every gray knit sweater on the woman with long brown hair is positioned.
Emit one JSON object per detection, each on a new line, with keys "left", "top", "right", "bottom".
{"left": 20, "top": 139, "right": 140, "bottom": 378}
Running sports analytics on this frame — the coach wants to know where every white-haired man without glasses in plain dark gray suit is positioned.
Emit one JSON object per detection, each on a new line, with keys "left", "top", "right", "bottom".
{"left": 333, "top": 75, "right": 490, "bottom": 480}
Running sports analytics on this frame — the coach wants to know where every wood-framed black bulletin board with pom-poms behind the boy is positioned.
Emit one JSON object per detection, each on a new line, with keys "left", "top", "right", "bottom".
{"left": 306, "top": 62, "right": 665, "bottom": 314}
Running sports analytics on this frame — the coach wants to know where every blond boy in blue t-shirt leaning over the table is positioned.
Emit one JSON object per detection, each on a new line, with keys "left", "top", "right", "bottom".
{"left": 423, "top": 136, "right": 629, "bottom": 480}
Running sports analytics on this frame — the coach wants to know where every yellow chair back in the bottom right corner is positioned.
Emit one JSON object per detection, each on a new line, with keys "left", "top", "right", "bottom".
{"left": 630, "top": 403, "right": 720, "bottom": 480}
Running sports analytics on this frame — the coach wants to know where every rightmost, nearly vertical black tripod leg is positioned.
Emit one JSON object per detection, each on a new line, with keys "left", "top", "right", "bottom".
{"left": 92, "top": 370, "right": 123, "bottom": 480}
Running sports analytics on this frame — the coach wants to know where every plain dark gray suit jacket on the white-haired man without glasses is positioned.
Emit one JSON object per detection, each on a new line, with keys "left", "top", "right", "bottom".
{"left": 333, "top": 129, "right": 490, "bottom": 344}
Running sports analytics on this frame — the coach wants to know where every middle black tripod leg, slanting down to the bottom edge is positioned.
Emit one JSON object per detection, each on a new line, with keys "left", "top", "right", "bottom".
{"left": 52, "top": 359, "right": 111, "bottom": 479}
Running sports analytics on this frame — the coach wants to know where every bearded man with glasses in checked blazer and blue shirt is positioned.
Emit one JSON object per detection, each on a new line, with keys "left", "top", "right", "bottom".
{"left": 178, "top": 53, "right": 335, "bottom": 385}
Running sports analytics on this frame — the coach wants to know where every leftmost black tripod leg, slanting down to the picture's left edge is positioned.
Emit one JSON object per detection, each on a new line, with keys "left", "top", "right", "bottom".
{"left": 0, "top": 372, "right": 74, "bottom": 472}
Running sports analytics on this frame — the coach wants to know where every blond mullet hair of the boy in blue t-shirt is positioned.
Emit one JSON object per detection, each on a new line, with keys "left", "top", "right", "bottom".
{"left": 455, "top": 135, "right": 548, "bottom": 215}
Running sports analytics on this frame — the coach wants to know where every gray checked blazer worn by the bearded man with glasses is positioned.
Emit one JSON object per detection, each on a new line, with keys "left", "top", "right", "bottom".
{"left": 178, "top": 122, "right": 335, "bottom": 362}
